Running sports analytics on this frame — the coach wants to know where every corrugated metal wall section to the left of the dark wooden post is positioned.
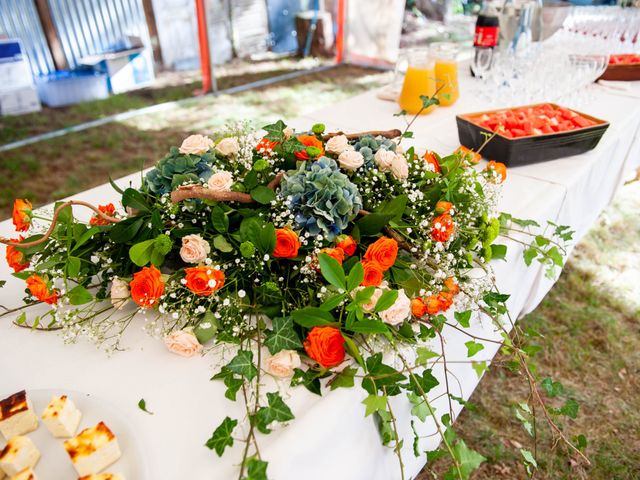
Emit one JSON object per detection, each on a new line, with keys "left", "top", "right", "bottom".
{"left": 0, "top": 0, "right": 55, "bottom": 75}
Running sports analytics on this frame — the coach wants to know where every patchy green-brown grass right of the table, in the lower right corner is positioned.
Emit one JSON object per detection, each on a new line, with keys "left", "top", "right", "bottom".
{"left": 419, "top": 182, "right": 640, "bottom": 480}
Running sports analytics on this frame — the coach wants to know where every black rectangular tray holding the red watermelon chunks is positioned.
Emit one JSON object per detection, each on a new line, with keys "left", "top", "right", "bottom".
{"left": 456, "top": 102, "right": 609, "bottom": 167}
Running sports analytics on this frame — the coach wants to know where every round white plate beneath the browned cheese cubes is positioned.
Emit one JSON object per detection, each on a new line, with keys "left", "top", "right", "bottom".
{"left": 0, "top": 390, "right": 148, "bottom": 480}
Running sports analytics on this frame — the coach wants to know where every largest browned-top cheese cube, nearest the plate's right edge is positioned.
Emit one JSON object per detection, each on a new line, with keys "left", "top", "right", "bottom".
{"left": 64, "top": 422, "right": 121, "bottom": 477}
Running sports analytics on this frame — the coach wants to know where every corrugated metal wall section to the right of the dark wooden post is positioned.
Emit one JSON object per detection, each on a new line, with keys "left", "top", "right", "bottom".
{"left": 49, "top": 0, "right": 149, "bottom": 68}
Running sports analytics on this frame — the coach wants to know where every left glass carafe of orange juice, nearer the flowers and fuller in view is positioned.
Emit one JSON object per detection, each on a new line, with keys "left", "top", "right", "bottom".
{"left": 398, "top": 51, "right": 436, "bottom": 114}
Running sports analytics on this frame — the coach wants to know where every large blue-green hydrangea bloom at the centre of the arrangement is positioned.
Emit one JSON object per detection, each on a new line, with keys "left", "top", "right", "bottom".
{"left": 280, "top": 157, "right": 362, "bottom": 240}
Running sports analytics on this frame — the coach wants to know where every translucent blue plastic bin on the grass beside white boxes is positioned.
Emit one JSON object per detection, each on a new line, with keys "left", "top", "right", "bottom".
{"left": 36, "top": 70, "right": 109, "bottom": 107}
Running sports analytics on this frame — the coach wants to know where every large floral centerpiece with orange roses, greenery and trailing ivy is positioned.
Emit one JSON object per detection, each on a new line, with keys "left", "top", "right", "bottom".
{"left": 2, "top": 108, "right": 575, "bottom": 479}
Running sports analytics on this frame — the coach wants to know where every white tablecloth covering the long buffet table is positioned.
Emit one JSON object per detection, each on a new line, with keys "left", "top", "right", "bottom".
{"left": 0, "top": 69, "right": 640, "bottom": 480}
